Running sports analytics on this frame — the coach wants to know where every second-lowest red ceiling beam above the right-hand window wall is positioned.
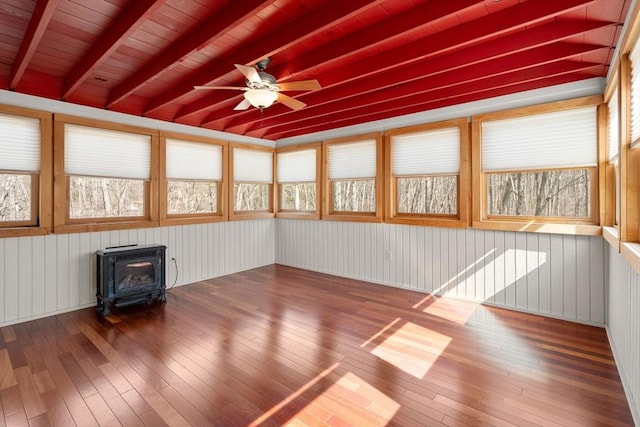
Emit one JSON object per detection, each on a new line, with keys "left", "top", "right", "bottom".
{"left": 252, "top": 43, "right": 602, "bottom": 138}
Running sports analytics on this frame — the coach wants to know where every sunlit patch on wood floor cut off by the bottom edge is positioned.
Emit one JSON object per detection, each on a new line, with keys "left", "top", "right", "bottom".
{"left": 285, "top": 372, "right": 400, "bottom": 427}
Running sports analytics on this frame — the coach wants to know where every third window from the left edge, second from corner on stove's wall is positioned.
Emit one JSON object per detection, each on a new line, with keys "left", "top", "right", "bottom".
{"left": 160, "top": 133, "right": 226, "bottom": 223}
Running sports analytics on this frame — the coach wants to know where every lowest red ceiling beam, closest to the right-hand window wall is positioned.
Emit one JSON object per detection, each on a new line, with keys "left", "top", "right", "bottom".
{"left": 260, "top": 67, "right": 601, "bottom": 140}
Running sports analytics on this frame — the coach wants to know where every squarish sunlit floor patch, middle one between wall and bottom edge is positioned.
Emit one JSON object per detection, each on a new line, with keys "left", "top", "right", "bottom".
{"left": 371, "top": 322, "right": 451, "bottom": 379}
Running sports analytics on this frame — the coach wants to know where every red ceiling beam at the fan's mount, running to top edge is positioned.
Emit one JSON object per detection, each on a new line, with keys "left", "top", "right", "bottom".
{"left": 144, "top": 0, "right": 383, "bottom": 114}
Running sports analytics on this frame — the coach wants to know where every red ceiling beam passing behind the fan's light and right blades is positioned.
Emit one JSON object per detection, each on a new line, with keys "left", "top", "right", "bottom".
{"left": 174, "top": 0, "right": 484, "bottom": 120}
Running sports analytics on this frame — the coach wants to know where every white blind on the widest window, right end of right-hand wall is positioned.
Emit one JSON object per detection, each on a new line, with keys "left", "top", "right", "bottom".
{"left": 482, "top": 106, "right": 597, "bottom": 171}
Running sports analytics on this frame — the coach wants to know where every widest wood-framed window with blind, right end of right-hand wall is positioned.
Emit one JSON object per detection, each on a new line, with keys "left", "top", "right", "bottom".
{"left": 473, "top": 97, "right": 601, "bottom": 234}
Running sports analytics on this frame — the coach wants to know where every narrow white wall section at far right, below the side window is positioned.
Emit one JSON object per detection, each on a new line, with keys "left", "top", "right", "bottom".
{"left": 607, "top": 248, "right": 640, "bottom": 424}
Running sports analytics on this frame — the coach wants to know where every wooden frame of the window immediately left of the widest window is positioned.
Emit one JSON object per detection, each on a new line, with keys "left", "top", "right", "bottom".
{"left": 384, "top": 118, "right": 471, "bottom": 228}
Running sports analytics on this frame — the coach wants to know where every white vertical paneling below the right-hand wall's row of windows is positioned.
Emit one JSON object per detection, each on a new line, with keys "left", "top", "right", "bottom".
{"left": 275, "top": 219, "right": 605, "bottom": 326}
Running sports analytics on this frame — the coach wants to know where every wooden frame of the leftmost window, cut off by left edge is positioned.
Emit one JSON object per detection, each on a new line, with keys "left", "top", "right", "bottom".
{"left": 0, "top": 104, "right": 53, "bottom": 238}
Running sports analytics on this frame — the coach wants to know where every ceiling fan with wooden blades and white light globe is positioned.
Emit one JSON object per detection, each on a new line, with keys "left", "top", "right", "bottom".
{"left": 194, "top": 58, "right": 321, "bottom": 110}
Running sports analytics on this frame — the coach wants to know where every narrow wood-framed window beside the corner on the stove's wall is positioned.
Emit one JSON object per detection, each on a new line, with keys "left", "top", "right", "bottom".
{"left": 229, "top": 144, "right": 273, "bottom": 218}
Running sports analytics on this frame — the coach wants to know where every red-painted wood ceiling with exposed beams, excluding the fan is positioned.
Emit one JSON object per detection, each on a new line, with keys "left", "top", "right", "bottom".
{"left": 0, "top": 0, "right": 630, "bottom": 140}
